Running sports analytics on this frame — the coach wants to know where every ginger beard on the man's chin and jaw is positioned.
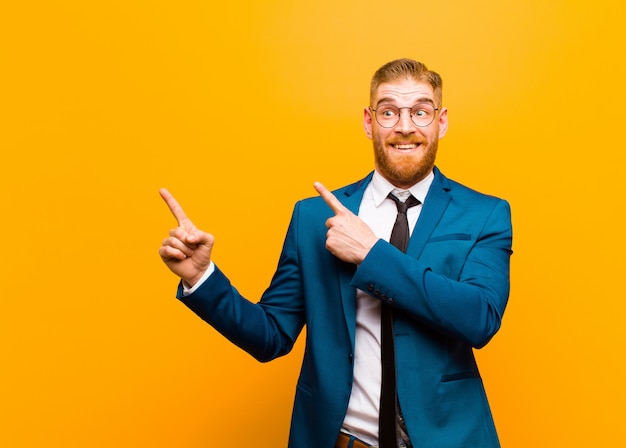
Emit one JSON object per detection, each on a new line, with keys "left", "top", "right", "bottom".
{"left": 372, "top": 131, "right": 439, "bottom": 188}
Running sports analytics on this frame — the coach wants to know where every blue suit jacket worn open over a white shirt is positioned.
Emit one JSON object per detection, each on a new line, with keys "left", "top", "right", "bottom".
{"left": 178, "top": 168, "right": 512, "bottom": 448}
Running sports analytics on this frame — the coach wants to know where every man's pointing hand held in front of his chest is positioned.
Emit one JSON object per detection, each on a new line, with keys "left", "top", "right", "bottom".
{"left": 313, "top": 182, "right": 378, "bottom": 264}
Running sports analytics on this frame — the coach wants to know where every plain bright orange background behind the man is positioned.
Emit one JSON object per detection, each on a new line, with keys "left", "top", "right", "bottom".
{"left": 0, "top": 0, "right": 626, "bottom": 448}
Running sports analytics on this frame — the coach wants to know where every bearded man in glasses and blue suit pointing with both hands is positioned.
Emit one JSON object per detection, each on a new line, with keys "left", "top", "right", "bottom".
{"left": 160, "top": 59, "right": 512, "bottom": 448}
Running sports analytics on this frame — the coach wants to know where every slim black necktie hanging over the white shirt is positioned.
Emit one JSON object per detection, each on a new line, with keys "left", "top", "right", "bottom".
{"left": 378, "top": 193, "right": 420, "bottom": 448}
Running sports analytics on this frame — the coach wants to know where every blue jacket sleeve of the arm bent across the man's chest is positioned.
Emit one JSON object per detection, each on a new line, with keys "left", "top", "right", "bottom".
{"left": 351, "top": 200, "right": 512, "bottom": 348}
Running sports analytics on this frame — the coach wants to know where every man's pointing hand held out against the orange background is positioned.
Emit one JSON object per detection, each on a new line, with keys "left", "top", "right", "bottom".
{"left": 159, "top": 188, "right": 215, "bottom": 287}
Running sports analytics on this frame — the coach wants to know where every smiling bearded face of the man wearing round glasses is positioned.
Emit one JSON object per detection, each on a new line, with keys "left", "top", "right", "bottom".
{"left": 363, "top": 78, "right": 448, "bottom": 188}
